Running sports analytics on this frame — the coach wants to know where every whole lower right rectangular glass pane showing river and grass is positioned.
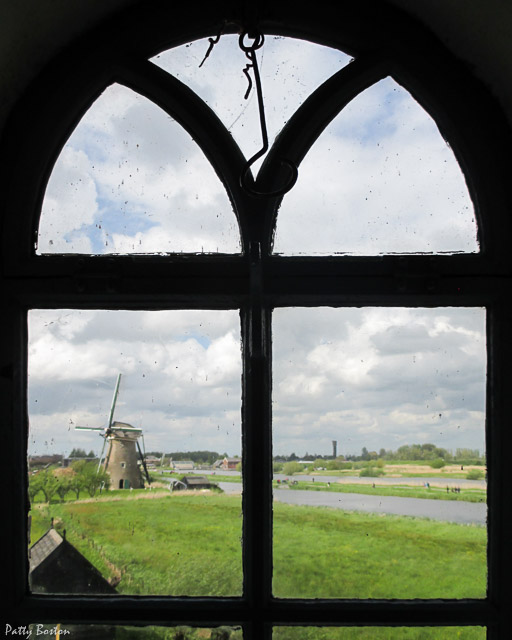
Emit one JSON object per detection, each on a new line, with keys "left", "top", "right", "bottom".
{"left": 273, "top": 308, "right": 487, "bottom": 599}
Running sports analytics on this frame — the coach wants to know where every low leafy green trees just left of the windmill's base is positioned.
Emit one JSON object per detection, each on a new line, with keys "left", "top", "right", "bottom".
{"left": 28, "top": 460, "right": 110, "bottom": 502}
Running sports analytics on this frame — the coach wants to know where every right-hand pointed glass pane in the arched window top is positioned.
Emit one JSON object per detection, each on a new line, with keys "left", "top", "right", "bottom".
{"left": 274, "top": 78, "right": 478, "bottom": 255}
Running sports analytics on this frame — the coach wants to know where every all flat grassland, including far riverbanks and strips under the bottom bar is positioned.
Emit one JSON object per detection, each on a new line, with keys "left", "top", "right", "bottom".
{"left": 31, "top": 462, "right": 487, "bottom": 640}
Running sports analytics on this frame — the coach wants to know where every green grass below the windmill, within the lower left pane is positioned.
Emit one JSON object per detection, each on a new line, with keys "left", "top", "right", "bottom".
{"left": 33, "top": 494, "right": 242, "bottom": 596}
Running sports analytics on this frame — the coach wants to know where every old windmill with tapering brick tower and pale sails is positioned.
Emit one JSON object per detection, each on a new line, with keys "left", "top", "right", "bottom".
{"left": 75, "top": 374, "right": 151, "bottom": 489}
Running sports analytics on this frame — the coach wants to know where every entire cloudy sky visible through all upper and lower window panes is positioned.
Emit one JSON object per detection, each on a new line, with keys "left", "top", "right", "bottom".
{"left": 29, "top": 36, "right": 486, "bottom": 455}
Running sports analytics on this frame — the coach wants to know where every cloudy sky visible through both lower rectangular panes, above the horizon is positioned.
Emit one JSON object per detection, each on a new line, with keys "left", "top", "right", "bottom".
{"left": 29, "top": 308, "right": 486, "bottom": 456}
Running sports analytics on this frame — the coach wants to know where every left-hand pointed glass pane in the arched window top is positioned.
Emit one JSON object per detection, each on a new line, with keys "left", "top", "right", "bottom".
{"left": 37, "top": 84, "right": 240, "bottom": 254}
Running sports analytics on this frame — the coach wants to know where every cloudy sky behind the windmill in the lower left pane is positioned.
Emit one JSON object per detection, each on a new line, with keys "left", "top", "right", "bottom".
{"left": 29, "top": 309, "right": 241, "bottom": 455}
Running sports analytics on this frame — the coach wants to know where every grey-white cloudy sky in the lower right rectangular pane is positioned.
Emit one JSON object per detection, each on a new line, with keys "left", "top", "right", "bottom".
{"left": 273, "top": 308, "right": 486, "bottom": 454}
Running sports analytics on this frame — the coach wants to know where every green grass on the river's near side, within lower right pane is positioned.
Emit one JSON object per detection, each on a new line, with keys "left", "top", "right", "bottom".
{"left": 273, "top": 504, "right": 486, "bottom": 598}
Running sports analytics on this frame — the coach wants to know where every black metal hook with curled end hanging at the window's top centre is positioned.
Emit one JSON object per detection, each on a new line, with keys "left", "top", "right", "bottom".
{"left": 238, "top": 30, "right": 298, "bottom": 198}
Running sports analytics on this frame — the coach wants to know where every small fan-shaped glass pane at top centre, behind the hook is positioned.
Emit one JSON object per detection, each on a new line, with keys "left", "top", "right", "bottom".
{"left": 151, "top": 34, "right": 351, "bottom": 166}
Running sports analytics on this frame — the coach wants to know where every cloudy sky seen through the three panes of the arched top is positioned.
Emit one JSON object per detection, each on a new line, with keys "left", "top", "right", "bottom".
{"left": 38, "top": 36, "right": 478, "bottom": 254}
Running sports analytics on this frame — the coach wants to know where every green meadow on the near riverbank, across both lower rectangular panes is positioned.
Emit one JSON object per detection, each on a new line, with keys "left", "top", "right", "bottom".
{"left": 32, "top": 494, "right": 486, "bottom": 598}
